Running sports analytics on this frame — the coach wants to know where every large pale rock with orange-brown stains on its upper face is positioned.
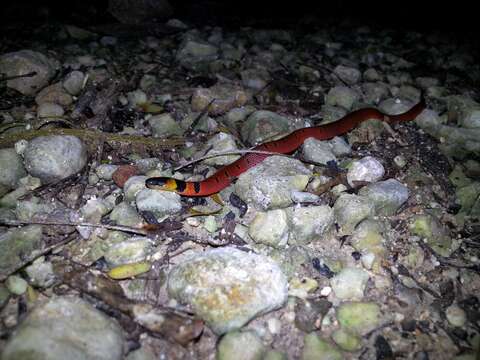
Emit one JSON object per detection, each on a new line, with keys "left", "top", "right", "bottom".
{"left": 168, "top": 247, "right": 288, "bottom": 335}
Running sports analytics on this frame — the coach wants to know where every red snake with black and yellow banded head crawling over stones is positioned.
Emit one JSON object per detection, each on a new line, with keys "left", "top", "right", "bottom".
{"left": 145, "top": 97, "right": 426, "bottom": 196}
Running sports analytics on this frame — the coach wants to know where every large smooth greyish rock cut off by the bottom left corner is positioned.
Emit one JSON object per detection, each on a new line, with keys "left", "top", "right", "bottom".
{"left": 0, "top": 297, "right": 124, "bottom": 360}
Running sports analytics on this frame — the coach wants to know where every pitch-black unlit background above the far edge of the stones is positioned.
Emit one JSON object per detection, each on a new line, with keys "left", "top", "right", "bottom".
{"left": 0, "top": 0, "right": 480, "bottom": 35}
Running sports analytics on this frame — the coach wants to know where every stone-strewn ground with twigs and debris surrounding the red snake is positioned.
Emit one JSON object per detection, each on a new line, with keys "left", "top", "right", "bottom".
{"left": 0, "top": 15, "right": 480, "bottom": 360}
